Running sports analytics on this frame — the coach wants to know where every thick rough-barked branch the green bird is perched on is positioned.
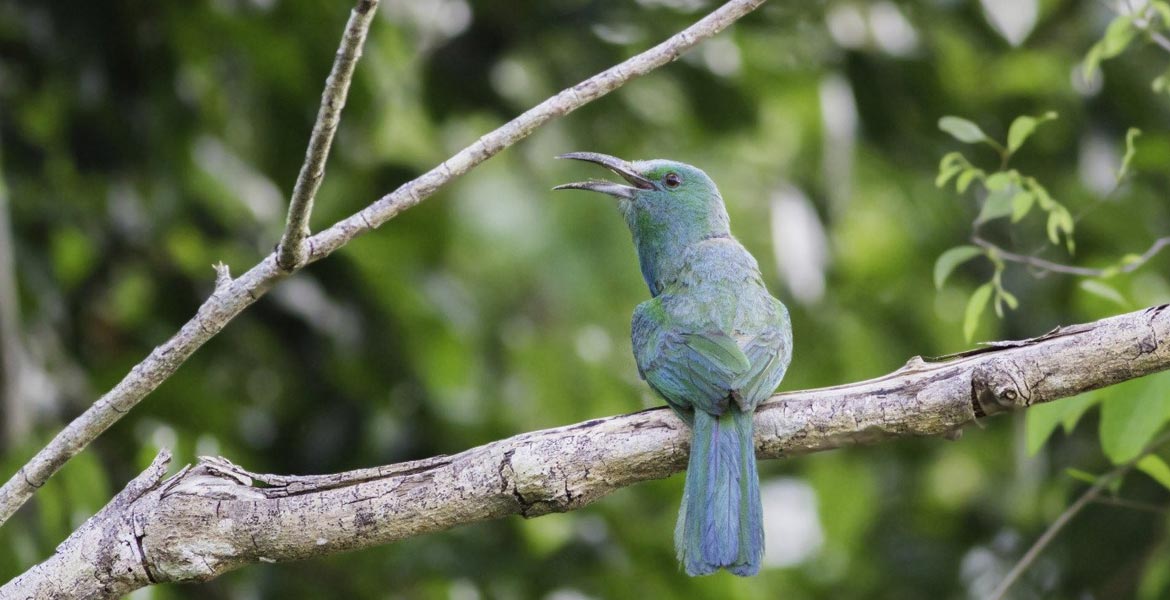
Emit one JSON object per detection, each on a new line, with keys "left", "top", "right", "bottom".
{"left": 9, "top": 305, "right": 1170, "bottom": 598}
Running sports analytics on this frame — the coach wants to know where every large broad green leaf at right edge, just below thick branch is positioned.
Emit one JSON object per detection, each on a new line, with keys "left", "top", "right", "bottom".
{"left": 1099, "top": 374, "right": 1170, "bottom": 464}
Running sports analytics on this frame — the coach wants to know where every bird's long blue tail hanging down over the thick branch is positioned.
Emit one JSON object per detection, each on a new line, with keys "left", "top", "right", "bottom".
{"left": 674, "top": 404, "right": 764, "bottom": 575}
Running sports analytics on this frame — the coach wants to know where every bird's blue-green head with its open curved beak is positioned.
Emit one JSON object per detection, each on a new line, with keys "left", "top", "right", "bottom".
{"left": 553, "top": 152, "right": 729, "bottom": 239}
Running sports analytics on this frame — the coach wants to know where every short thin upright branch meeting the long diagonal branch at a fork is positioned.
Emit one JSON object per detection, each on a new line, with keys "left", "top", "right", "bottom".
{"left": 277, "top": 0, "right": 379, "bottom": 270}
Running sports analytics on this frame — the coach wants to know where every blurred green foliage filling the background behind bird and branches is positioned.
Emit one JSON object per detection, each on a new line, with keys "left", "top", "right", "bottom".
{"left": 0, "top": 0, "right": 1170, "bottom": 600}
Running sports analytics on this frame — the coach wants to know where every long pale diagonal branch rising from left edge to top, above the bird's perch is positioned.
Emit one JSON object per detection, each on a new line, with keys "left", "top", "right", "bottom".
{"left": 0, "top": 0, "right": 764, "bottom": 524}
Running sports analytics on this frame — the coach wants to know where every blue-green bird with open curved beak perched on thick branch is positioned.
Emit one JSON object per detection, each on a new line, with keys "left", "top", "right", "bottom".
{"left": 555, "top": 152, "right": 792, "bottom": 575}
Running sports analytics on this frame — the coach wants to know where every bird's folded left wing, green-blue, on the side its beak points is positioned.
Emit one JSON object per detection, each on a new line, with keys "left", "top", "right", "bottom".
{"left": 633, "top": 298, "right": 752, "bottom": 414}
